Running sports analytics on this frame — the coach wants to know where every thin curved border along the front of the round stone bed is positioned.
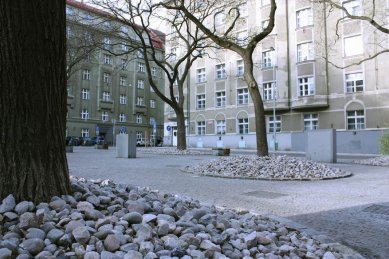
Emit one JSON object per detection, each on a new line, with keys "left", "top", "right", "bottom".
{"left": 180, "top": 169, "right": 354, "bottom": 182}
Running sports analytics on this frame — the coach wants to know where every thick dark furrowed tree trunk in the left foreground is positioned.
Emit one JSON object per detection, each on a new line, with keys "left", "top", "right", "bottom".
{"left": 0, "top": 0, "right": 70, "bottom": 202}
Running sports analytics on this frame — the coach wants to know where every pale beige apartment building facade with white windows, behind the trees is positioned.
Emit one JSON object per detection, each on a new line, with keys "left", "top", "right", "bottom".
{"left": 165, "top": 0, "right": 389, "bottom": 153}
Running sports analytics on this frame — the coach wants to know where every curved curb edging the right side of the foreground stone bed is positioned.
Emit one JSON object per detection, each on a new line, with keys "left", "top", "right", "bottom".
{"left": 263, "top": 214, "right": 366, "bottom": 259}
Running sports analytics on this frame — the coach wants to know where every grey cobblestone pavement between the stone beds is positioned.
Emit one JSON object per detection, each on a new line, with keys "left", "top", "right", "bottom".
{"left": 68, "top": 147, "right": 389, "bottom": 258}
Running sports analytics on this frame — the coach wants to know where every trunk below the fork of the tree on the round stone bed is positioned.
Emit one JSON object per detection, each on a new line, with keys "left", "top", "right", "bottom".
{"left": 245, "top": 69, "right": 269, "bottom": 156}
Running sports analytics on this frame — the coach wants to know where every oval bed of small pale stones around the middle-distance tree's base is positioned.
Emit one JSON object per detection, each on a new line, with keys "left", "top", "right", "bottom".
{"left": 185, "top": 155, "right": 351, "bottom": 180}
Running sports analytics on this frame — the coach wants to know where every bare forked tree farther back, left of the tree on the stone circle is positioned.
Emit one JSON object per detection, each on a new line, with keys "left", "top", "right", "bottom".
{"left": 89, "top": 0, "right": 209, "bottom": 150}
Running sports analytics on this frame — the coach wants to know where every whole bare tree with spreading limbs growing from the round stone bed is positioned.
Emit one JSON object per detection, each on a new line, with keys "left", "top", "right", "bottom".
{"left": 161, "top": 0, "right": 277, "bottom": 156}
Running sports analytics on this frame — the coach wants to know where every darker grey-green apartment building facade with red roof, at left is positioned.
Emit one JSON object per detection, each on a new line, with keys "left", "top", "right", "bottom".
{"left": 66, "top": 0, "right": 164, "bottom": 144}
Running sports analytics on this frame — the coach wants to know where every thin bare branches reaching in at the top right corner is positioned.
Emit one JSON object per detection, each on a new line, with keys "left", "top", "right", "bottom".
{"left": 311, "top": 0, "right": 389, "bottom": 69}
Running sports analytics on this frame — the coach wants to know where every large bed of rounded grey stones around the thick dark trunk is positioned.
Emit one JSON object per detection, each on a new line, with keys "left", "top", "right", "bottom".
{"left": 0, "top": 178, "right": 343, "bottom": 259}
